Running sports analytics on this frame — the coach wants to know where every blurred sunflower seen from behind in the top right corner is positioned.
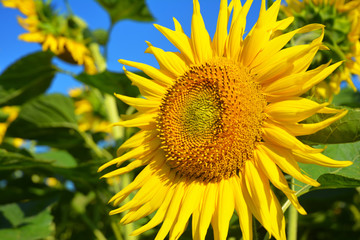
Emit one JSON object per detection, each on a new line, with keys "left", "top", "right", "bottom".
{"left": 282, "top": 0, "right": 360, "bottom": 100}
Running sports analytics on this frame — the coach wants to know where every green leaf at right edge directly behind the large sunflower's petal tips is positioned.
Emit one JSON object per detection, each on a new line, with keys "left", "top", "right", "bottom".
{"left": 299, "top": 108, "right": 360, "bottom": 144}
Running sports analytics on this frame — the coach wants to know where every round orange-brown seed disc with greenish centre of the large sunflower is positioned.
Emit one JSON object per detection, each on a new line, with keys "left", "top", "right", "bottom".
{"left": 157, "top": 59, "right": 266, "bottom": 182}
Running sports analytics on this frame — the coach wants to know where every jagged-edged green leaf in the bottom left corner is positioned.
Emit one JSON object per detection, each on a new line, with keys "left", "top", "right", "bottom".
{"left": 0, "top": 203, "right": 53, "bottom": 240}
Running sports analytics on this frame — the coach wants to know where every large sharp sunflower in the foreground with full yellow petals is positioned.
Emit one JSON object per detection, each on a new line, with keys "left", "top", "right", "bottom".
{"left": 99, "top": 0, "right": 351, "bottom": 239}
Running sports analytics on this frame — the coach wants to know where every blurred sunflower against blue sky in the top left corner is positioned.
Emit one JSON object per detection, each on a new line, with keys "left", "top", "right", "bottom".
{"left": 2, "top": 0, "right": 97, "bottom": 74}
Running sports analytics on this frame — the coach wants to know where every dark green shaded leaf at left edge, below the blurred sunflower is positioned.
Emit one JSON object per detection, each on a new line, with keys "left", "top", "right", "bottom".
{"left": 0, "top": 52, "right": 55, "bottom": 106}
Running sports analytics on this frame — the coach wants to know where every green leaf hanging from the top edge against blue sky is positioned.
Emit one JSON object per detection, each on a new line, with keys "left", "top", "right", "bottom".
{"left": 96, "top": 0, "right": 154, "bottom": 24}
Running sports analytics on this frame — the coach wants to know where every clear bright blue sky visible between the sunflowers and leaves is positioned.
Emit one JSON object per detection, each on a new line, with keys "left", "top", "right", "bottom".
{"left": 0, "top": 0, "right": 261, "bottom": 93}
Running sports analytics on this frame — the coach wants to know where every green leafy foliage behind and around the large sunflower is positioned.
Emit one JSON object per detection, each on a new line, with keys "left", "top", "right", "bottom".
{"left": 0, "top": 0, "right": 360, "bottom": 240}
